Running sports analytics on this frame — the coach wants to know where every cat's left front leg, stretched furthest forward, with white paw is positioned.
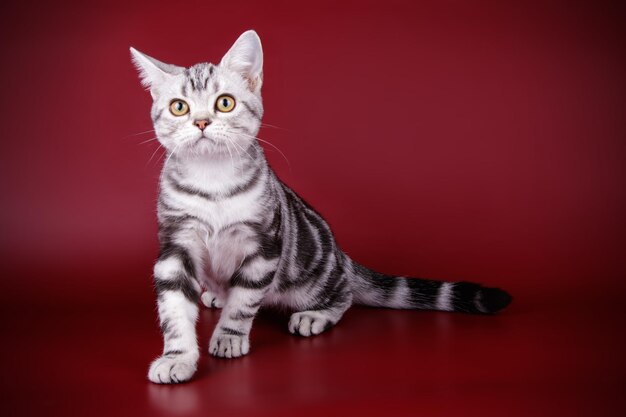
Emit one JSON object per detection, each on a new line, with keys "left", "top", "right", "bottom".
{"left": 148, "top": 247, "right": 200, "bottom": 384}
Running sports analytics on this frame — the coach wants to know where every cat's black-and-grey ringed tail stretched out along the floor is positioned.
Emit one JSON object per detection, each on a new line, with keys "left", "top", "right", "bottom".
{"left": 346, "top": 256, "right": 512, "bottom": 314}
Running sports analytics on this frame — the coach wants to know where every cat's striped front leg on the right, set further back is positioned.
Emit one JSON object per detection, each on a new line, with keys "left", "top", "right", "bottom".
{"left": 209, "top": 254, "right": 278, "bottom": 358}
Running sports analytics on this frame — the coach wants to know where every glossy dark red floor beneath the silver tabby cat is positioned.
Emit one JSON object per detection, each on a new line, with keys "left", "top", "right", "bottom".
{"left": 1, "top": 290, "right": 626, "bottom": 417}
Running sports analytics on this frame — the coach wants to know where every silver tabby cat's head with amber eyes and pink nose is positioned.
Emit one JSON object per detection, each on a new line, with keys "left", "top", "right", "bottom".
{"left": 130, "top": 30, "right": 263, "bottom": 155}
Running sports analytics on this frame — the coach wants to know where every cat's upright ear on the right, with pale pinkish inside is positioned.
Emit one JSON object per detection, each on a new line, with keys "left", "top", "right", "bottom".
{"left": 220, "top": 30, "right": 263, "bottom": 93}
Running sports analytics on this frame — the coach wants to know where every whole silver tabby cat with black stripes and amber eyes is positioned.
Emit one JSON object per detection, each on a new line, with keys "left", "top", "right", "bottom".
{"left": 130, "top": 30, "right": 511, "bottom": 384}
